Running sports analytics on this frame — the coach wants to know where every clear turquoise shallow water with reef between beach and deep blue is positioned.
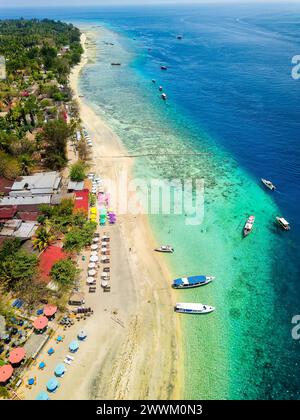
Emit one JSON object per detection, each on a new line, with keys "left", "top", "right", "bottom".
{"left": 81, "top": 24, "right": 290, "bottom": 398}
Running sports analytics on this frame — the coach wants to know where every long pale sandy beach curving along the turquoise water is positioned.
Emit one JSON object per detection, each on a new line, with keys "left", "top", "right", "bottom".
{"left": 23, "top": 32, "right": 182, "bottom": 399}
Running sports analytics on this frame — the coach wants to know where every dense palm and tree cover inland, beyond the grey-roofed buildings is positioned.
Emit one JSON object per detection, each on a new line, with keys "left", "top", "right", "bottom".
{"left": 0, "top": 19, "right": 84, "bottom": 179}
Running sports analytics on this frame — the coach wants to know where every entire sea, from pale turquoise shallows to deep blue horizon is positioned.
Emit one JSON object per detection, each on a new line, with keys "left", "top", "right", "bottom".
{"left": 0, "top": 4, "right": 300, "bottom": 399}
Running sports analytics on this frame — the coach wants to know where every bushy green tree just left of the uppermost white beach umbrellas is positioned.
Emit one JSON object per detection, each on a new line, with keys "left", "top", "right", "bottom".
{"left": 64, "top": 222, "right": 97, "bottom": 252}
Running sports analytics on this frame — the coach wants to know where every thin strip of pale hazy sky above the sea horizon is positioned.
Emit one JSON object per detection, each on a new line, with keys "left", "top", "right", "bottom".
{"left": 0, "top": 0, "right": 299, "bottom": 8}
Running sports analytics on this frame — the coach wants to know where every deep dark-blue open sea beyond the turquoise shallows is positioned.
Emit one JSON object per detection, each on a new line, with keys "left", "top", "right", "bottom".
{"left": 0, "top": 2, "right": 300, "bottom": 398}
